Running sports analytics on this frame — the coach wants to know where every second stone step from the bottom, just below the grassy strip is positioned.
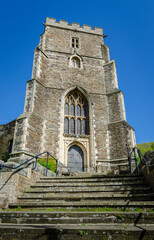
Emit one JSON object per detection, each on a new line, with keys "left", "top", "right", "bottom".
{"left": 0, "top": 211, "right": 154, "bottom": 224}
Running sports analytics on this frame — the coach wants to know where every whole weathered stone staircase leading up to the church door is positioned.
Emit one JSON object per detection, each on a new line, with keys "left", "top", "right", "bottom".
{"left": 0, "top": 174, "right": 154, "bottom": 240}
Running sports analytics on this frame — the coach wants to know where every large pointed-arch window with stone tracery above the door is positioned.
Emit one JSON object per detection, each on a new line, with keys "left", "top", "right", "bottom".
{"left": 64, "top": 90, "right": 89, "bottom": 136}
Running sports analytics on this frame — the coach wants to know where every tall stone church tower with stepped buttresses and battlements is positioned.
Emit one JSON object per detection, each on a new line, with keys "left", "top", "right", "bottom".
{"left": 0, "top": 18, "right": 135, "bottom": 172}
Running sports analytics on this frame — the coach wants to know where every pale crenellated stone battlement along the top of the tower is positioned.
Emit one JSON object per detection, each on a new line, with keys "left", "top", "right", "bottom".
{"left": 45, "top": 17, "right": 103, "bottom": 35}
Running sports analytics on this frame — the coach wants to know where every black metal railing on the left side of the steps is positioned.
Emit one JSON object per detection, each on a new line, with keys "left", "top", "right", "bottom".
{"left": 0, "top": 152, "right": 58, "bottom": 176}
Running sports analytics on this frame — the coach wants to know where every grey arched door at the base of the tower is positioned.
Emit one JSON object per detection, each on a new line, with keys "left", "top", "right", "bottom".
{"left": 67, "top": 145, "right": 84, "bottom": 172}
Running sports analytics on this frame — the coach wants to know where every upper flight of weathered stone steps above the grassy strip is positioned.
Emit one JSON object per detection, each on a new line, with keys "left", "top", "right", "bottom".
{"left": 10, "top": 174, "right": 154, "bottom": 209}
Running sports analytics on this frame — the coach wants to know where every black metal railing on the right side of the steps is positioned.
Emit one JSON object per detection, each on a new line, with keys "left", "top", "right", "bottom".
{"left": 126, "top": 144, "right": 151, "bottom": 173}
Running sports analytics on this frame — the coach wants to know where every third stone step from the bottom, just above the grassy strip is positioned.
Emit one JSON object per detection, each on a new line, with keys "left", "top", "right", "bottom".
{"left": 9, "top": 199, "right": 154, "bottom": 209}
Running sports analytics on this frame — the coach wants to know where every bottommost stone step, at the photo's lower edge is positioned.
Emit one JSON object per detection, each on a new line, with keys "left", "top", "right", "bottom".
{"left": 0, "top": 223, "right": 154, "bottom": 240}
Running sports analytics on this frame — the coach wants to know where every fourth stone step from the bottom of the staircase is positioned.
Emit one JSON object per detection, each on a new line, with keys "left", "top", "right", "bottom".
{"left": 18, "top": 192, "right": 154, "bottom": 201}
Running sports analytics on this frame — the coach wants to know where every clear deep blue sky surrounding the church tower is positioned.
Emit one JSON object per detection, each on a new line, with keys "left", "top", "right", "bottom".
{"left": 0, "top": 0, "right": 154, "bottom": 143}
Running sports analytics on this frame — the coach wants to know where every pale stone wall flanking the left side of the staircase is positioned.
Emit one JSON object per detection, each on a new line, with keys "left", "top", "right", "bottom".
{"left": 0, "top": 161, "right": 55, "bottom": 208}
